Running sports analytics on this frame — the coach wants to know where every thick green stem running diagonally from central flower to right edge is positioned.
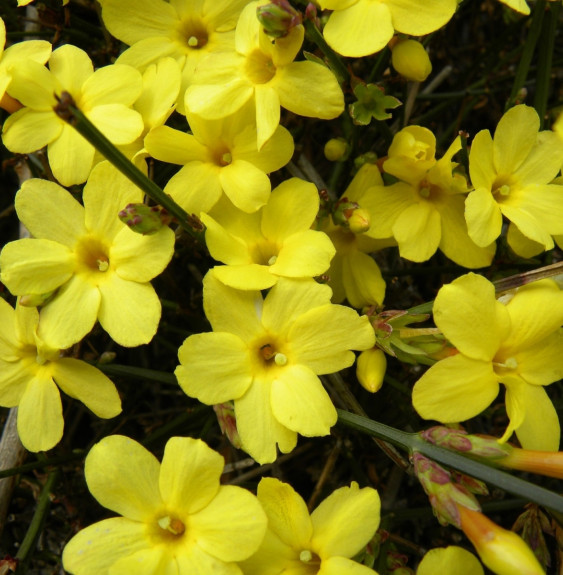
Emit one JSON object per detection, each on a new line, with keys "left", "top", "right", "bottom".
{"left": 337, "top": 409, "right": 563, "bottom": 513}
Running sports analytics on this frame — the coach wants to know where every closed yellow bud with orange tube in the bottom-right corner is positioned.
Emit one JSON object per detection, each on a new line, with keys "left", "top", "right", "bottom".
{"left": 458, "top": 505, "right": 545, "bottom": 575}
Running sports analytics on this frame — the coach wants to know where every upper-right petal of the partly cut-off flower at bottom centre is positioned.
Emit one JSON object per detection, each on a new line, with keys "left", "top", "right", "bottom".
{"left": 311, "top": 482, "right": 381, "bottom": 557}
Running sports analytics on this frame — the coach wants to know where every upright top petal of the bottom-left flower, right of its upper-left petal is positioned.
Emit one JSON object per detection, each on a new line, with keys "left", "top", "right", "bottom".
{"left": 159, "top": 437, "right": 225, "bottom": 516}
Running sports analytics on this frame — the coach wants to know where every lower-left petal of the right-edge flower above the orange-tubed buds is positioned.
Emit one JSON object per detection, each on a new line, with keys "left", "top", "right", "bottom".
{"left": 412, "top": 354, "right": 499, "bottom": 423}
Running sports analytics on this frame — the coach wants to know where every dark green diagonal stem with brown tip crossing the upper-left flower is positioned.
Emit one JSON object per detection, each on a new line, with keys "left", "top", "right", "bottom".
{"left": 55, "top": 96, "right": 201, "bottom": 240}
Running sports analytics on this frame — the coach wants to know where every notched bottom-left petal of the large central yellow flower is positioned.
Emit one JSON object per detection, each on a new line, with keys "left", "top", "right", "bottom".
{"left": 235, "top": 379, "right": 297, "bottom": 464}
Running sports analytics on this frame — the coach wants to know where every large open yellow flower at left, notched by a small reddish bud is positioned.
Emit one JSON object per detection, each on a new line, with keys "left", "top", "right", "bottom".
{"left": 0, "top": 162, "right": 174, "bottom": 349}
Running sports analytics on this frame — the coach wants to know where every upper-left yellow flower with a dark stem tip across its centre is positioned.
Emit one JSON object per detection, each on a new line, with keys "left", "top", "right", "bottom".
{"left": 2, "top": 44, "right": 143, "bottom": 186}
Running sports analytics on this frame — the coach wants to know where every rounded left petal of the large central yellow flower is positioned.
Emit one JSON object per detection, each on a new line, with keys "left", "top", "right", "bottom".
{"left": 175, "top": 332, "right": 252, "bottom": 405}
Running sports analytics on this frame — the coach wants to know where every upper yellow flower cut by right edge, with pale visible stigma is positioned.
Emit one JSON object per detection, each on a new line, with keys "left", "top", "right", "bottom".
{"left": 465, "top": 105, "right": 563, "bottom": 255}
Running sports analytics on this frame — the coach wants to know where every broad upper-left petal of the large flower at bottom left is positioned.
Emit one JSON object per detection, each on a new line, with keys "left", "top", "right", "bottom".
{"left": 84, "top": 435, "right": 162, "bottom": 522}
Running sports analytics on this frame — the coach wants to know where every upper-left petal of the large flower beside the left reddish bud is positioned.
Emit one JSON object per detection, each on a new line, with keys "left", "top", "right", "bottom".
{"left": 15, "top": 178, "right": 86, "bottom": 244}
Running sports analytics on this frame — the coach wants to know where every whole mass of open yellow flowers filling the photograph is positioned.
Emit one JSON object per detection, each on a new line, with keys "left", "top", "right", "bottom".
{"left": 0, "top": 0, "right": 563, "bottom": 575}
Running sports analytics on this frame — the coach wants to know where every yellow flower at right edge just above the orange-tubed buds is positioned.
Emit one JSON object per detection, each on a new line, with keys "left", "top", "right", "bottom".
{"left": 413, "top": 273, "right": 563, "bottom": 451}
